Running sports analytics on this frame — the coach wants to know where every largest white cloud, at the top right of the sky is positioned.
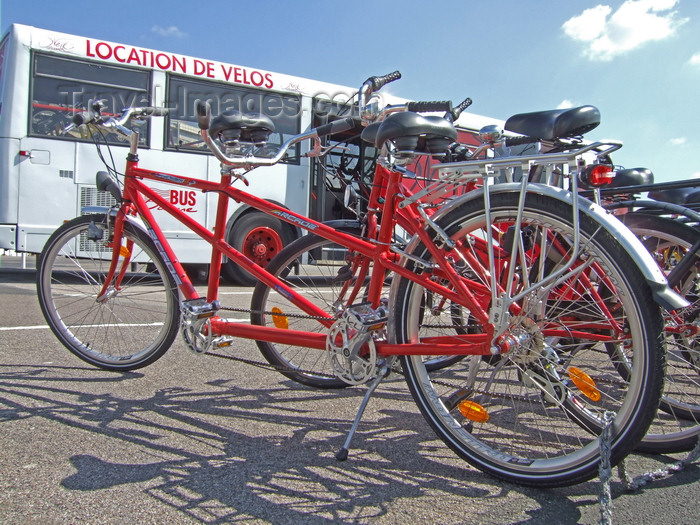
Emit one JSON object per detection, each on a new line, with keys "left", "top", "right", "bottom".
{"left": 562, "top": 0, "right": 688, "bottom": 61}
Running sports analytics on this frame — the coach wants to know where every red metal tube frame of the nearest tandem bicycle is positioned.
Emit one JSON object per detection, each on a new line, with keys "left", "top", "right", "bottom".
{"left": 100, "top": 151, "right": 493, "bottom": 356}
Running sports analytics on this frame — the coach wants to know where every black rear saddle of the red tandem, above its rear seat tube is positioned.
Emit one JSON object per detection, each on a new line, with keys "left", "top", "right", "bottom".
{"left": 362, "top": 111, "right": 457, "bottom": 153}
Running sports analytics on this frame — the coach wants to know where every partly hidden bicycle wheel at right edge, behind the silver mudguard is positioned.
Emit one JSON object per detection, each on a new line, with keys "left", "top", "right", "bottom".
{"left": 621, "top": 213, "right": 700, "bottom": 453}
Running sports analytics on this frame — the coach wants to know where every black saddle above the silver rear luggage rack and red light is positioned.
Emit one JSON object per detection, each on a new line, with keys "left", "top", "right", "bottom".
{"left": 505, "top": 106, "right": 600, "bottom": 140}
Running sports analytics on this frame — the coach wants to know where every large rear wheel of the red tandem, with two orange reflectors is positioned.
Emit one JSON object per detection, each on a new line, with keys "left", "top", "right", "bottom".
{"left": 392, "top": 192, "right": 664, "bottom": 487}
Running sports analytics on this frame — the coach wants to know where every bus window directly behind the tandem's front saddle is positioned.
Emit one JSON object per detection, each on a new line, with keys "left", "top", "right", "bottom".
{"left": 170, "top": 72, "right": 301, "bottom": 164}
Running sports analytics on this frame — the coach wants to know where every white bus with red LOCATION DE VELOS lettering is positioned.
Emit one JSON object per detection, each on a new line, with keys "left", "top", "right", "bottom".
{"left": 0, "top": 24, "right": 492, "bottom": 283}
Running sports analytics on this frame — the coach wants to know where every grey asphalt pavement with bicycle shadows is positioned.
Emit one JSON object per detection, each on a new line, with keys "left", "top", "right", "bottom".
{"left": 0, "top": 257, "right": 700, "bottom": 525}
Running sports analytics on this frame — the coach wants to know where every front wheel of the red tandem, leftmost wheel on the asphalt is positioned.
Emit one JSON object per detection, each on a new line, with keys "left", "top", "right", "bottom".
{"left": 37, "top": 215, "right": 179, "bottom": 371}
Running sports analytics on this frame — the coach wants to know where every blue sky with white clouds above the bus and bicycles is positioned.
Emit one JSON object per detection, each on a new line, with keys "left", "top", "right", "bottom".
{"left": 0, "top": 0, "right": 700, "bottom": 181}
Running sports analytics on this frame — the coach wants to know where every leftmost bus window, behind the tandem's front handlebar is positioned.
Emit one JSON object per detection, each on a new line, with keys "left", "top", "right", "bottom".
{"left": 29, "top": 53, "right": 150, "bottom": 146}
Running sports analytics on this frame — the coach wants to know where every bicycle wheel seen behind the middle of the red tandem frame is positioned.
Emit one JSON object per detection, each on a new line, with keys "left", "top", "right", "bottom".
{"left": 251, "top": 230, "right": 362, "bottom": 388}
